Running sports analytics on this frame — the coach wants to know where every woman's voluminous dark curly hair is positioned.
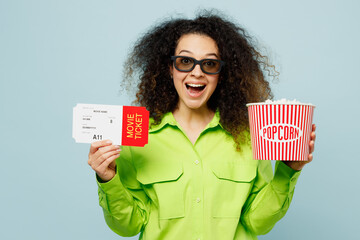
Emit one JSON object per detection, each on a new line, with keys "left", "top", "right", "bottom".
{"left": 123, "top": 12, "right": 278, "bottom": 150}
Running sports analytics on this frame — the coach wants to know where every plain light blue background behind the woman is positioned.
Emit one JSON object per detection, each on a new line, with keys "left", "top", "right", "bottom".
{"left": 0, "top": 0, "right": 360, "bottom": 240}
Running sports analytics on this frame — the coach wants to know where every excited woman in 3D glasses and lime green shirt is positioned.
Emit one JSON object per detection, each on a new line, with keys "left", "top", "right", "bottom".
{"left": 88, "top": 12, "right": 315, "bottom": 240}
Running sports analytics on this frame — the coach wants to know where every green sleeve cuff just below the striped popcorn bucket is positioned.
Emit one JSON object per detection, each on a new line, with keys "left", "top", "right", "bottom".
{"left": 271, "top": 161, "right": 301, "bottom": 192}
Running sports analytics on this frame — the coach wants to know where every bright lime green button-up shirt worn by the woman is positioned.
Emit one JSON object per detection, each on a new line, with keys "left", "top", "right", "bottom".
{"left": 98, "top": 112, "right": 300, "bottom": 240}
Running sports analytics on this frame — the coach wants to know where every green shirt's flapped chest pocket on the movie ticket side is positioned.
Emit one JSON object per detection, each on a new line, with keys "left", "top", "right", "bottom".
{"left": 137, "top": 160, "right": 185, "bottom": 219}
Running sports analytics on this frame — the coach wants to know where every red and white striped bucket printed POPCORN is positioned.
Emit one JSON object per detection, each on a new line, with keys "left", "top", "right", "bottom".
{"left": 246, "top": 103, "right": 315, "bottom": 161}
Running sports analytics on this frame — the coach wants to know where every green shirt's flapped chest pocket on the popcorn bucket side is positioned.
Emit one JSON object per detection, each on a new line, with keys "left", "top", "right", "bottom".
{"left": 211, "top": 161, "right": 257, "bottom": 218}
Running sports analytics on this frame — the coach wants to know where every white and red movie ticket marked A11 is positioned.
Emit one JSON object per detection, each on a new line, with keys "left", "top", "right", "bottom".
{"left": 72, "top": 103, "right": 149, "bottom": 147}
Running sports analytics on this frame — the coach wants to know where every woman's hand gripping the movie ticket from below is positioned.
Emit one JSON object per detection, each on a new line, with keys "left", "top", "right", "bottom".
{"left": 88, "top": 140, "right": 121, "bottom": 182}
